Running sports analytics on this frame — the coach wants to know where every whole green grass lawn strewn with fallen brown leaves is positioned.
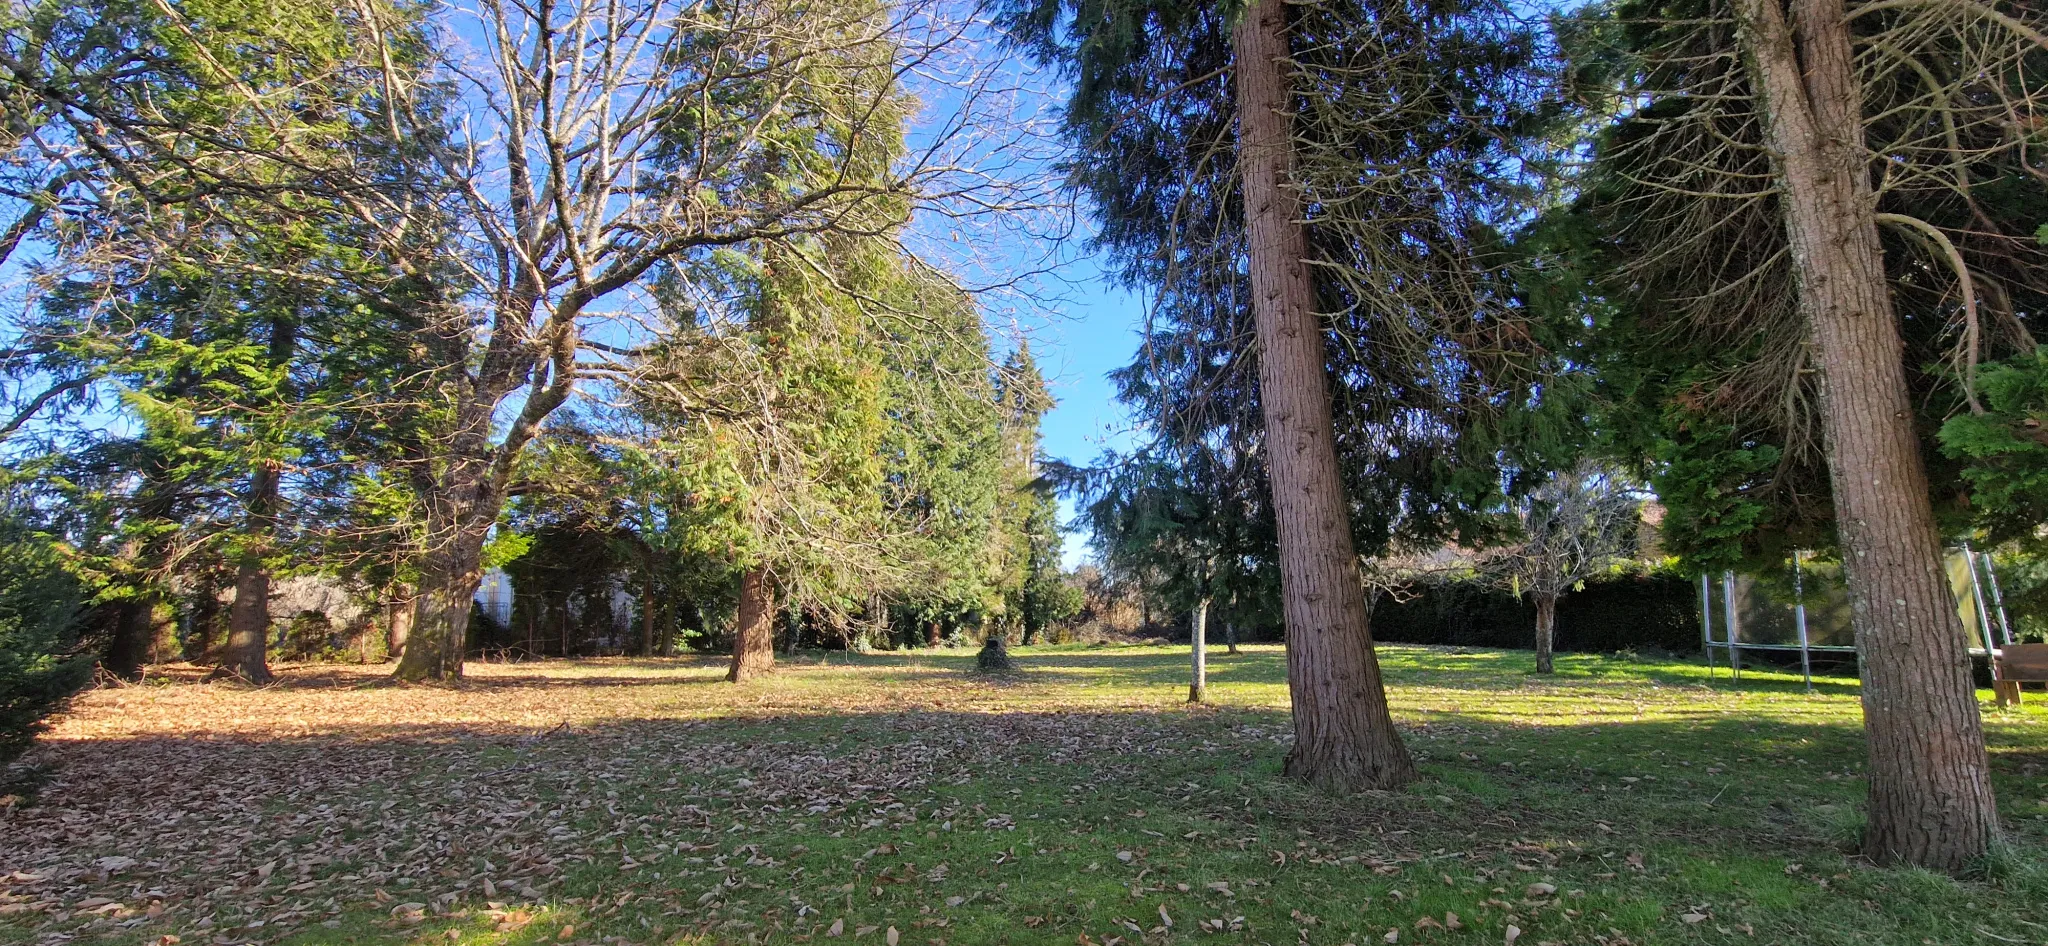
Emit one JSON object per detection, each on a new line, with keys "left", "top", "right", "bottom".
{"left": 0, "top": 647, "right": 2048, "bottom": 946}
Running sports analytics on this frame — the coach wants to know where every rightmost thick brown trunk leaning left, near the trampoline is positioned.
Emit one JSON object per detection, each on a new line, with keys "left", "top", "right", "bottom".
{"left": 1739, "top": 0, "right": 1999, "bottom": 872}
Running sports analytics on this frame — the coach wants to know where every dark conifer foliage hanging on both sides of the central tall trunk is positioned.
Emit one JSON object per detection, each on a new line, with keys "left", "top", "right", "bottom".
{"left": 999, "top": 0, "right": 1556, "bottom": 606}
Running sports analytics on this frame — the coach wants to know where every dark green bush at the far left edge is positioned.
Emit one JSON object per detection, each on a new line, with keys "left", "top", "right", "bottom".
{"left": 0, "top": 512, "right": 92, "bottom": 762}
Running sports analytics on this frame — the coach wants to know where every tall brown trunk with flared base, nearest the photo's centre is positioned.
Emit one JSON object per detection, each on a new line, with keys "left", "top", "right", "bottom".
{"left": 1233, "top": 0, "right": 1415, "bottom": 792}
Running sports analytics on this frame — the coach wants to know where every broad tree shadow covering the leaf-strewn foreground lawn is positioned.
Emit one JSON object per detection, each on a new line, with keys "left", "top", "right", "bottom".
{"left": 16, "top": 688, "right": 2048, "bottom": 942}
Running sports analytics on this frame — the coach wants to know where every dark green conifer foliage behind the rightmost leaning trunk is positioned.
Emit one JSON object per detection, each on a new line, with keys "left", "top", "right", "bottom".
{"left": 1520, "top": 0, "right": 2048, "bottom": 571}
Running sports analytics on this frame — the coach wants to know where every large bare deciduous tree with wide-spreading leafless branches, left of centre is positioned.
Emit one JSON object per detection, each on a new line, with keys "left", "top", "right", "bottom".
{"left": 327, "top": 0, "right": 1064, "bottom": 680}
